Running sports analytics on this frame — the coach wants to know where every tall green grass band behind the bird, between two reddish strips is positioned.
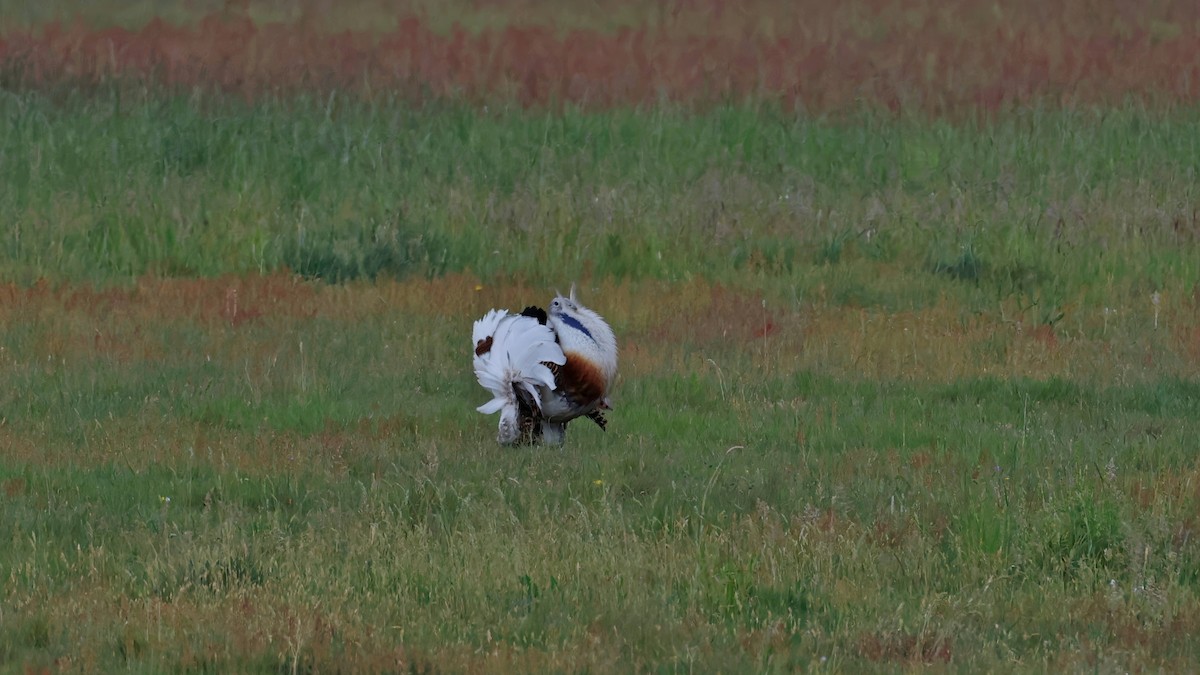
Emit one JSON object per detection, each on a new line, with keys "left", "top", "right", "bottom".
{"left": 0, "top": 86, "right": 1200, "bottom": 305}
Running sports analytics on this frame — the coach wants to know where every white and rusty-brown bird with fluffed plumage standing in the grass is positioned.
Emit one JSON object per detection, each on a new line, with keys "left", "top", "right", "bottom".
{"left": 472, "top": 286, "right": 617, "bottom": 446}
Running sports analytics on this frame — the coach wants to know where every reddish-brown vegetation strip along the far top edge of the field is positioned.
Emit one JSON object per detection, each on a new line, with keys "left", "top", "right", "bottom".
{"left": 0, "top": 0, "right": 1200, "bottom": 114}
